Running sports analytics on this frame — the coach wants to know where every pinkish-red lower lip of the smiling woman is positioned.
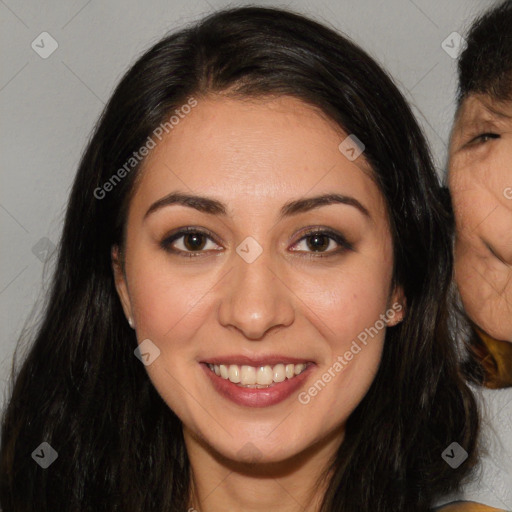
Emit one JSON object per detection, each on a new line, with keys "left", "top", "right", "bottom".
{"left": 201, "top": 363, "right": 315, "bottom": 407}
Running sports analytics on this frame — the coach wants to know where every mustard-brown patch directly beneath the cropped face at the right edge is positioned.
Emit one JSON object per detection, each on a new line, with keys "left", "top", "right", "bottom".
{"left": 474, "top": 326, "right": 512, "bottom": 389}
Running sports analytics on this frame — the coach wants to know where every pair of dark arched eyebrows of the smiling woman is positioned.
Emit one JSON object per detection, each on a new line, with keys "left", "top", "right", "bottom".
{"left": 144, "top": 192, "right": 371, "bottom": 220}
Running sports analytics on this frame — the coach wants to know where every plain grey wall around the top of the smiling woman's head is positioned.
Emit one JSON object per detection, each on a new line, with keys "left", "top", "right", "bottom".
{"left": 0, "top": 0, "right": 495, "bottom": 407}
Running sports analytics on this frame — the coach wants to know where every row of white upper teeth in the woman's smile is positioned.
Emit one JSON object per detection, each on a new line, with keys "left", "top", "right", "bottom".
{"left": 208, "top": 363, "right": 307, "bottom": 386}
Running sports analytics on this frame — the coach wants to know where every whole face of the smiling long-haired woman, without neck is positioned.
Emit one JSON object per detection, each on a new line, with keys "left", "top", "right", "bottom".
{"left": 113, "top": 97, "right": 401, "bottom": 462}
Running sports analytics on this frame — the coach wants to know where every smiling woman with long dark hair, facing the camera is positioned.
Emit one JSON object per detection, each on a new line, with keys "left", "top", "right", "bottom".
{"left": 0, "top": 8, "right": 478, "bottom": 512}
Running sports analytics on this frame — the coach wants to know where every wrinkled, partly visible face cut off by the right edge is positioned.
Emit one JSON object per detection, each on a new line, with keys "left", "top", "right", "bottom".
{"left": 449, "top": 94, "right": 512, "bottom": 341}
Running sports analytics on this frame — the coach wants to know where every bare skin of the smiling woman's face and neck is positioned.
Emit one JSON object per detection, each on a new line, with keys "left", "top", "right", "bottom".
{"left": 113, "top": 96, "right": 404, "bottom": 512}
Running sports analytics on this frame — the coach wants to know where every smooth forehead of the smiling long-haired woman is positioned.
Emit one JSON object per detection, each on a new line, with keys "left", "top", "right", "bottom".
{"left": 134, "top": 97, "right": 381, "bottom": 216}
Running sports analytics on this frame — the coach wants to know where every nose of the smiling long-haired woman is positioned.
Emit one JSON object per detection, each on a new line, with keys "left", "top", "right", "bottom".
{"left": 218, "top": 250, "right": 295, "bottom": 341}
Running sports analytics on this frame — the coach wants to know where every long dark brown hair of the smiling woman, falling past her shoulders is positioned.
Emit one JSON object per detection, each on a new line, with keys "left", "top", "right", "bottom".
{"left": 0, "top": 7, "right": 478, "bottom": 512}
